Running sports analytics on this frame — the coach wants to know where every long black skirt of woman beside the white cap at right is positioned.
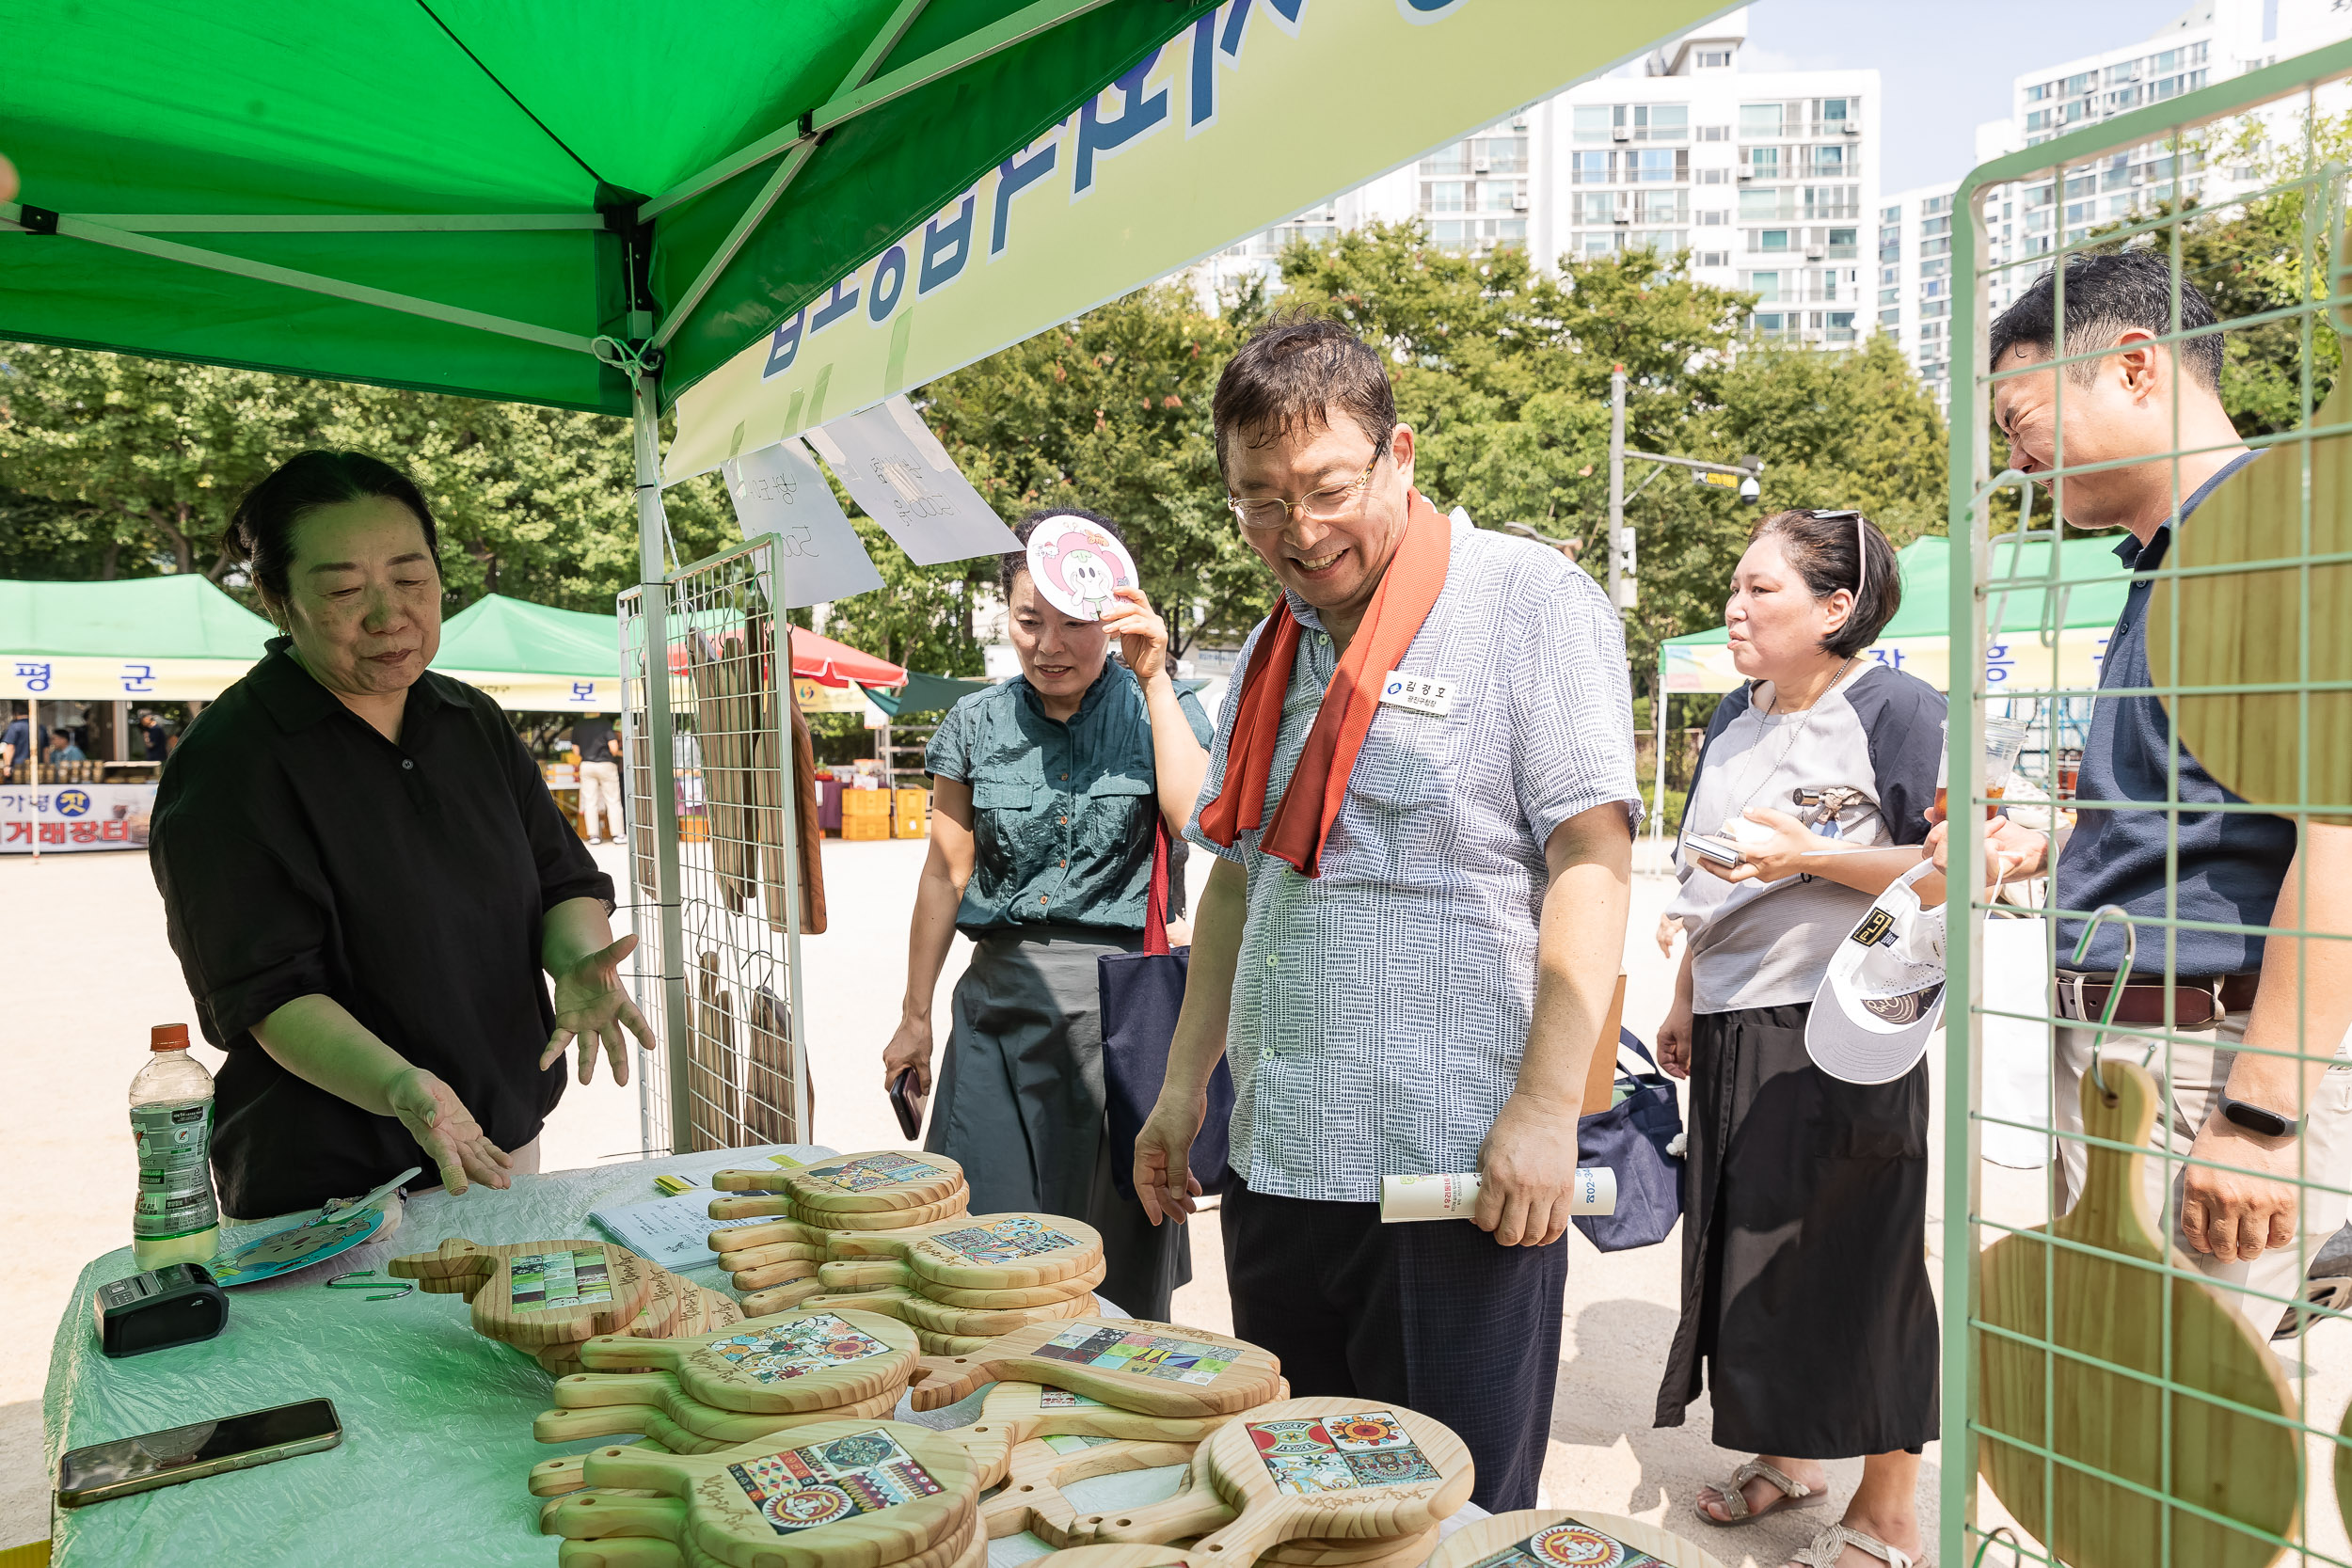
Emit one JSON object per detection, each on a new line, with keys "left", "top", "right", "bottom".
{"left": 1659, "top": 1004, "right": 1938, "bottom": 1460}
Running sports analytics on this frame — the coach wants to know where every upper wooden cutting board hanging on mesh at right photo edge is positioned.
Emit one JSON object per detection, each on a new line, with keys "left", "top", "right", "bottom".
{"left": 2148, "top": 376, "right": 2352, "bottom": 823}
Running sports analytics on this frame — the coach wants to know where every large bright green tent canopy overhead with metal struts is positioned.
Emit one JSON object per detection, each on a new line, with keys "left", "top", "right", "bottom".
{"left": 0, "top": 0, "right": 1209, "bottom": 414}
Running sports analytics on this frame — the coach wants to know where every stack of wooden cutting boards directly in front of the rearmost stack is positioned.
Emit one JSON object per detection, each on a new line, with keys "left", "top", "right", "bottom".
{"left": 771, "top": 1213, "right": 1104, "bottom": 1356}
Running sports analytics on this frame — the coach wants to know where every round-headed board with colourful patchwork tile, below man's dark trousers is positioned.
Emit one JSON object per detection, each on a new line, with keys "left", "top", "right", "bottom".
{"left": 1071, "top": 1397, "right": 1477, "bottom": 1563}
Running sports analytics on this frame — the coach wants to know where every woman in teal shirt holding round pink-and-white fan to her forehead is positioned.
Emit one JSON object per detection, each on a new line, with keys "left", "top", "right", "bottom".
{"left": 882, "top": 510, "right": 1212, "bottom": 1319}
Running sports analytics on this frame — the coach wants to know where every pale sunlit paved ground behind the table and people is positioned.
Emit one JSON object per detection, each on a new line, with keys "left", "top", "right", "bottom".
{"left": 0, "top": 842, "right": 2352, "bottom": 1568}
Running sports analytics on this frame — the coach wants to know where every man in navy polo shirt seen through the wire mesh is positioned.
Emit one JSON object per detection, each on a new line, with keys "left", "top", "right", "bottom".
{"left": 1936, "top": 251, "right": 2352, "bottom": 1333}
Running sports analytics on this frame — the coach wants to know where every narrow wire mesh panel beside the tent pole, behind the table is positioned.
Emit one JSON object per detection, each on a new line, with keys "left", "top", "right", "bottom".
{"left": 621, "top": 538, "right": 809, "bottom": 1152}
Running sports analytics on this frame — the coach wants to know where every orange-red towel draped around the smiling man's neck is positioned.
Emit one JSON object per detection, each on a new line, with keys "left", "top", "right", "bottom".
{"left": 1200, "top": 491, "right": 1454, "bottom": 877}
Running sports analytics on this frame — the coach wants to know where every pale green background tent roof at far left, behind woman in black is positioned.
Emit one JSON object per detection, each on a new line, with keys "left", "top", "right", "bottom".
{"left": 0, "top": 574, "right": 276, "bottom": 660}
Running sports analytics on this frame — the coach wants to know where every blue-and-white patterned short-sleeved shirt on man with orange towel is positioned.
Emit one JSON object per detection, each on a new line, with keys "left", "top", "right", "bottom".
{"left": 1185, "top": 524, "right": 1642, "bottom": 1201}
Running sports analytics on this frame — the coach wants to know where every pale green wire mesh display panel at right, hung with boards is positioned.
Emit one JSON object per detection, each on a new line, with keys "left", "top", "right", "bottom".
{"left": 1938, "top": 33, "right": 2352, "bottom": 1568}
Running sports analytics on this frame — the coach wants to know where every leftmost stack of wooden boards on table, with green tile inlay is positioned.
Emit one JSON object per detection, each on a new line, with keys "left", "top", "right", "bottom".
{"left": 386, "top": 1237, "right": 743, "bottom": 1378}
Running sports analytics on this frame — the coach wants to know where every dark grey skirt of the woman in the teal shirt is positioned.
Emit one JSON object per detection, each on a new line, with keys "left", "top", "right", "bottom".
{"left": 925, "top": 927, "right": 1193, "bottom": 1319}
